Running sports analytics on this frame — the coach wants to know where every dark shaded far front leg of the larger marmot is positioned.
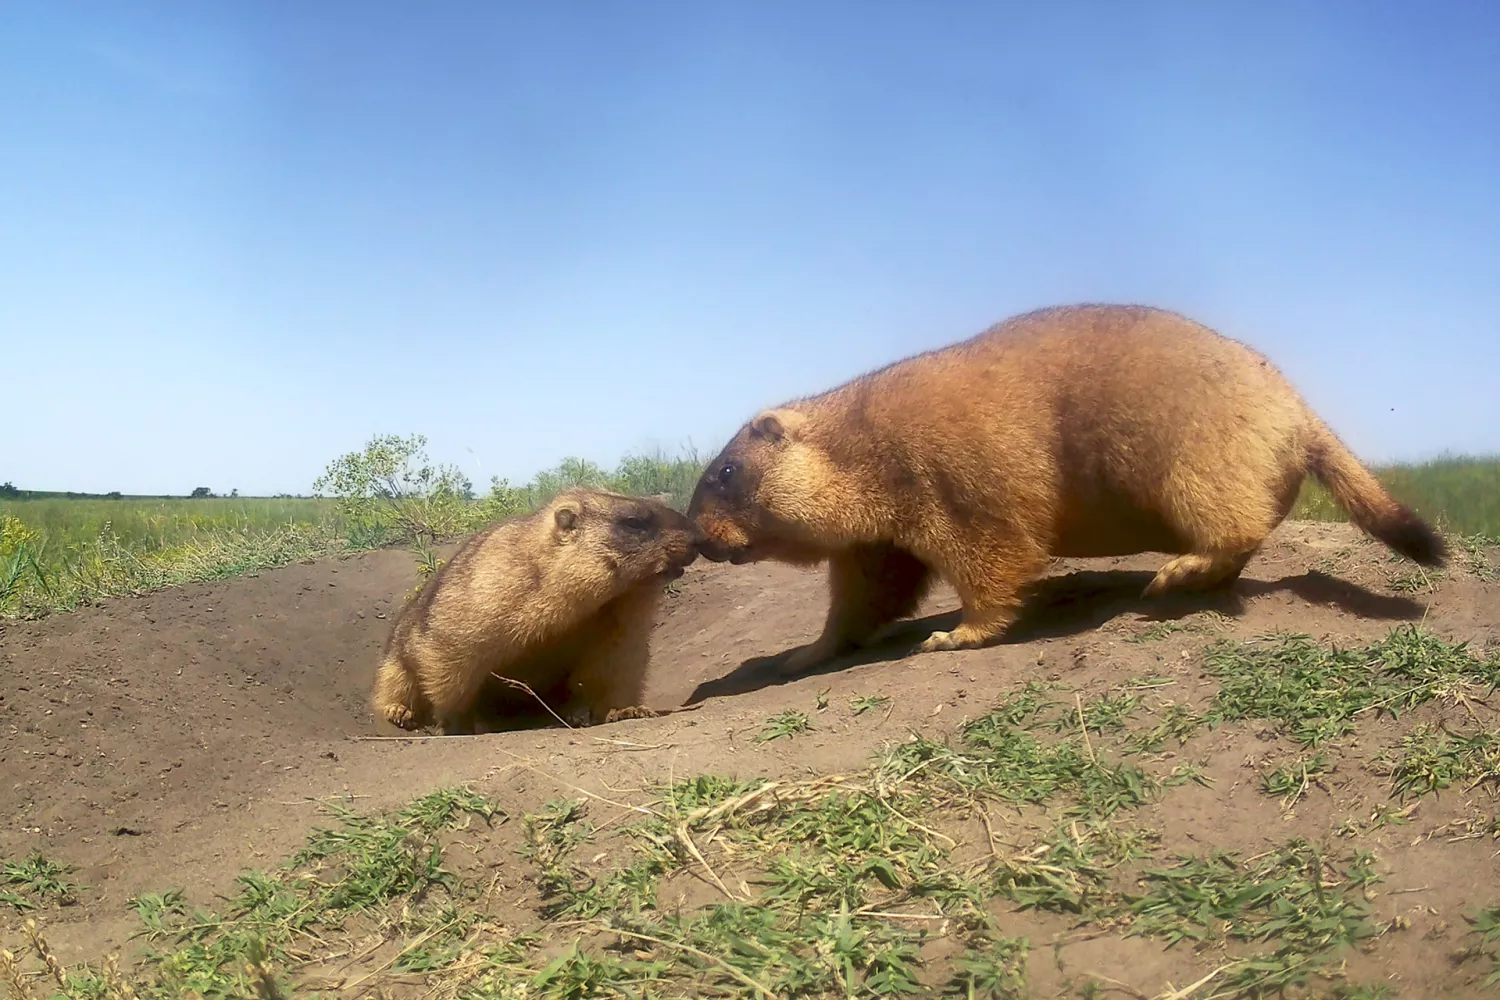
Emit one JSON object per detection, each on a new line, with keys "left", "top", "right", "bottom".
{"left": 780, "top": 543, "right": 933, "bottom": 675}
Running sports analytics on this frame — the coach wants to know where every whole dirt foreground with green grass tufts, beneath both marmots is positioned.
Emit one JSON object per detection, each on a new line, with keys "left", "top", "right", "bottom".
{"left": 0, "top": 523, "right": 1500, "bottom": 1000}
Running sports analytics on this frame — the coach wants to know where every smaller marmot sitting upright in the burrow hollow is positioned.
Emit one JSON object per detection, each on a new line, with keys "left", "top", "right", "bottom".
{"left": 372, "top": 489, "right": 698, "bottom": 732}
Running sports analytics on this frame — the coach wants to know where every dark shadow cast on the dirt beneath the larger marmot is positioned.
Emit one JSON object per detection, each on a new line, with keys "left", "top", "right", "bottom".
{"left": 687, "top": 570, "right": 1422, "bottom": 705}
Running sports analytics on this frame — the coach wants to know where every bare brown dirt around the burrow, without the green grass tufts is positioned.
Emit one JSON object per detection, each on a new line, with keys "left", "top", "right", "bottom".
{"left": 0, "top": 523, "right": 1500, "bottom": 996}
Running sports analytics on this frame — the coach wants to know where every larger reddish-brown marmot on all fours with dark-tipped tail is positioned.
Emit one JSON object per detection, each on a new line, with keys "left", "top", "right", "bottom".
{"left": 689, "top": 304, "right": 1446, "bottom": 672}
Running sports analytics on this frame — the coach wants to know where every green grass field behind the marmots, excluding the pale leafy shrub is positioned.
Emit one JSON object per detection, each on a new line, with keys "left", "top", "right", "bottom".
{"left": 0, "top": 454, "right": 1500, "bottom": 618}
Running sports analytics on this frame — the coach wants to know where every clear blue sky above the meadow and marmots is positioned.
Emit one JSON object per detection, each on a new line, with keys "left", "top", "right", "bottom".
{"left": 0, "top": 0, "right": 1500, "bottom": 493}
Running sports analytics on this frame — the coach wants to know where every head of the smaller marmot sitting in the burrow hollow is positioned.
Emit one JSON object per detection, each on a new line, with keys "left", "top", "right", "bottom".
{"left": 543, "top": 487, "right": 698, "bottom": 586}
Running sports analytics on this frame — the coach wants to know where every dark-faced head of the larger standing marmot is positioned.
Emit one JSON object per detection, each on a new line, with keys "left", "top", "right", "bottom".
{"left": 687, "top": 408, "right": 828, "bottom": 565}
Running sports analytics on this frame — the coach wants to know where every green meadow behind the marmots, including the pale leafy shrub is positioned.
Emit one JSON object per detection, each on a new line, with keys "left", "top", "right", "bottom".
{"left": 0, "top": 436, "right": 1500, "bottom": 618}
